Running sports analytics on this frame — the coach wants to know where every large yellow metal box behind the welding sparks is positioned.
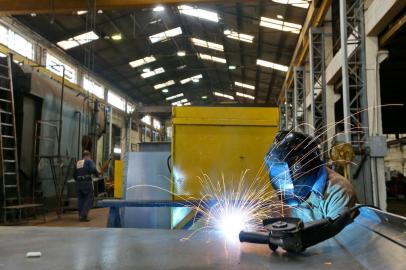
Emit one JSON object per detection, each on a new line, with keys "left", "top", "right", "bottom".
{"left": 172, "top": 107, "right": 279, "bottom": 199}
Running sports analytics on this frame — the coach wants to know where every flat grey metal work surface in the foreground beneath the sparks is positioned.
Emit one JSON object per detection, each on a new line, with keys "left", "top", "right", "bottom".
{"left": 0, "top": 207, "right": 406, "bottom": 270}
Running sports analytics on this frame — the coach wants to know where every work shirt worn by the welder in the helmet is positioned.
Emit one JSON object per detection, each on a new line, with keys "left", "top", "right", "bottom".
{"left": 291, "top": 168, "right": 357, "bottom": 222}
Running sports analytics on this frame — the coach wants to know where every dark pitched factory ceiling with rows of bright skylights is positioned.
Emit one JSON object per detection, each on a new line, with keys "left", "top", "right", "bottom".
{"left": 15, "top": 0, "right": 307, "bottom": 106}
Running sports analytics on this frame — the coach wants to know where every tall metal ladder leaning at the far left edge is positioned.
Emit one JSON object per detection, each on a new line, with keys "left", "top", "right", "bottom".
{"left": 0, "top": 54, "right": 21, "bottom": 223}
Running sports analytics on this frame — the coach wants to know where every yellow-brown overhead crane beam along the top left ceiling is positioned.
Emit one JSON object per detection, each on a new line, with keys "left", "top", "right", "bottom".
{"left": 0, "top": 0, "right": 241, "bottom": 15}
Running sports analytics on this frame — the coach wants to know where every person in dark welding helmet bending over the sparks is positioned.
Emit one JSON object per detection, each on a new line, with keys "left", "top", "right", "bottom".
{"left": 265, "top": 131, "right": 357, "bottom": 222}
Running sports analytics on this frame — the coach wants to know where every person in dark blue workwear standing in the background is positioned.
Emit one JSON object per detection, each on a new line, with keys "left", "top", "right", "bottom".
{"left": 73, "top": 151, "right": 99, "bottom": 221}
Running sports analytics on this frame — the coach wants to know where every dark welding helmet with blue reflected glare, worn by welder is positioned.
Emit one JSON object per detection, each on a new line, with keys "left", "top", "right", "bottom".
{"left": 265, "top": 131, "right": 327, "bottom": 205}
